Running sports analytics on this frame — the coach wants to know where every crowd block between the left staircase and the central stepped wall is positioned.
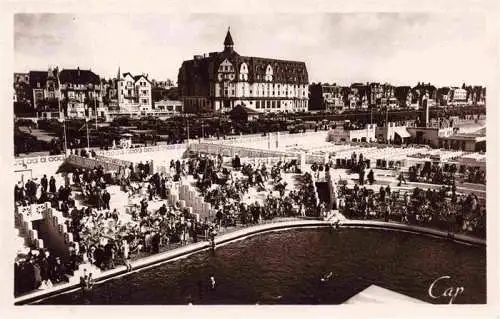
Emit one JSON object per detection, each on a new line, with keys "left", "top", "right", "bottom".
{"left": 62, "top": 163, "right": 215, "bottom": 269}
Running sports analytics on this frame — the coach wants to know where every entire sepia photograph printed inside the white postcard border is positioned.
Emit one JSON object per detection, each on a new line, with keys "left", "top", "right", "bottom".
{"left": 8, "top": 11, "right": 496, "bottom": 307}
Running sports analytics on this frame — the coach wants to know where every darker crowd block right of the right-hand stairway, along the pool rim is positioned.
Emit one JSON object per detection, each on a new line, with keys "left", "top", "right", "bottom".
{"left": 337, "top": 184, "right": 486, "bottom": 237}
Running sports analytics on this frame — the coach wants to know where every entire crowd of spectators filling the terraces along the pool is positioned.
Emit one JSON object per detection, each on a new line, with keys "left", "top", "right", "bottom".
{"left": 14, "top": 144, "right": 486, "bottom": 298}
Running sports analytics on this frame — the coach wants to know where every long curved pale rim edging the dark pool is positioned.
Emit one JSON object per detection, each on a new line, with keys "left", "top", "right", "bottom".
{"left": 14, "top": 220, "right": 486, "bottom": 305}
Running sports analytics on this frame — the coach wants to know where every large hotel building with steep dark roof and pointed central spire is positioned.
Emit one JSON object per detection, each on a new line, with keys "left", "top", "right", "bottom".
{"left": 178, "top": 30, "right": 309, "bottom": 113}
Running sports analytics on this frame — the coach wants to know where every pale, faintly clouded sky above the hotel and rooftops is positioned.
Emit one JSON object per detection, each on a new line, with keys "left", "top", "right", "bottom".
{"left": 14, "top": 13, "right": 494, "bottom": 86}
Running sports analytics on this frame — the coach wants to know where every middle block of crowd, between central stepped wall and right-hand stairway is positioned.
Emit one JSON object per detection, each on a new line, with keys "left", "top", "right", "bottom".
{"left": 195, "top": 155, "right": 326, "bottom": 226}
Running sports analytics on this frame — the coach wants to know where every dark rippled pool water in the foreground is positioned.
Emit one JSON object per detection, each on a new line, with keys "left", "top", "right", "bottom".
{"left": 37, "top": 228, "right": 486, "bottom": 305}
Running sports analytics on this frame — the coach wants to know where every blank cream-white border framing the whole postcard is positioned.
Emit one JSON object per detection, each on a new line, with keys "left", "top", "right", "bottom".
{"left": 0, "top": 0, "right": 500, "bottom": 318}
